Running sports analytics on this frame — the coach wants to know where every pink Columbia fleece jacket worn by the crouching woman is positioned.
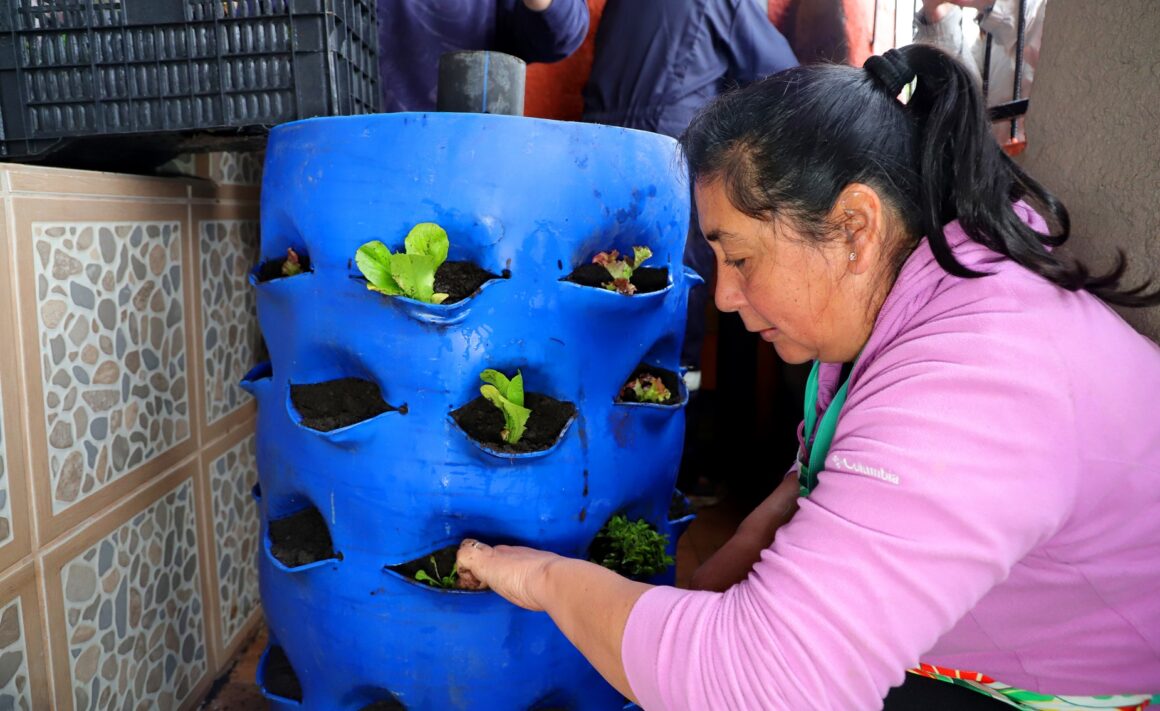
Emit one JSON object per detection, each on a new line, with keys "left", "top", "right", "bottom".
{"left": 623, "top": 205, "right": 1160, "bottom": 711}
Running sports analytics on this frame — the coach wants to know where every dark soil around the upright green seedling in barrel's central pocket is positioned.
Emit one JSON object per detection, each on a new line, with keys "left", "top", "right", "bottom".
{"left": 451, "top": 392, "right": 577, "bottom": 454}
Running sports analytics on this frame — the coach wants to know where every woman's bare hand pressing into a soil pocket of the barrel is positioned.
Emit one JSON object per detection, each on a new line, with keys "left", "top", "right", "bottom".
{"left": 456, "top": 538, "right": 560, "bottom": 611}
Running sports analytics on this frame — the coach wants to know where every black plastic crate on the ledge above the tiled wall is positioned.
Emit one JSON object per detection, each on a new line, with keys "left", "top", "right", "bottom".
{"left": 0, "top": 0, "right": 379, "bottom": 162}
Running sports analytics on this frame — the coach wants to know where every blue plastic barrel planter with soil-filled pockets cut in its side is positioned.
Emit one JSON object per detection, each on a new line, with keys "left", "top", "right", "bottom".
{"left": 245, "top": 114, "right": 696, "bottom": 710}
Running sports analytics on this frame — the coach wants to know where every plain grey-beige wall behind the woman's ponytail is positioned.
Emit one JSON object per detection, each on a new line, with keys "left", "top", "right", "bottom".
{"left": 1021, "top": 0, "right": 1160, "bottom": 341}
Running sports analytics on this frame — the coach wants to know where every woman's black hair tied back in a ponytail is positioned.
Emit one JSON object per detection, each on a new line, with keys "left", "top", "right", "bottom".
{"left": 681, "top": 44, "right": 1160, "bottom": 306}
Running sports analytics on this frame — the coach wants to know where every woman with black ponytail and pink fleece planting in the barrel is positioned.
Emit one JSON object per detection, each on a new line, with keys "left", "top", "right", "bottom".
{"left": 459, "top": 45, "right": 1160, "bottom": 711}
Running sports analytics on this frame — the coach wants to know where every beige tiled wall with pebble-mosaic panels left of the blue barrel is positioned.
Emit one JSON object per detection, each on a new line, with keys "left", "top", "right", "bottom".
{"left": 0, "top": 154, "right": 261, "bottom": 711}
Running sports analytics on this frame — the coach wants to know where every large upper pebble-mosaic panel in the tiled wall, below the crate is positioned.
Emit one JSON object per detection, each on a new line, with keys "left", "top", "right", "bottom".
{"left": 32, "top": 223, "right": 190, "bottom": 513}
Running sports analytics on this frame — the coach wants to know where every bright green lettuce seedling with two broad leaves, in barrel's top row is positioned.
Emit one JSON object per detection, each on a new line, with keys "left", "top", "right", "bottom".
{"left": 355, "top": 223, "right": 449, "bottom": 304}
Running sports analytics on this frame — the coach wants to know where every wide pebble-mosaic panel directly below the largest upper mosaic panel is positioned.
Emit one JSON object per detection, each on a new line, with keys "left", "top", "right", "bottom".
{"left": 60, "top": 480, "right": 206, "bottom": 711}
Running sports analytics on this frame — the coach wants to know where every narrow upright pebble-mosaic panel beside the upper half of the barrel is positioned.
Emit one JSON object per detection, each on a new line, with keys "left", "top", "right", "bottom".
{"left": 198, "top": 219, "right": 261, "bottom": 423}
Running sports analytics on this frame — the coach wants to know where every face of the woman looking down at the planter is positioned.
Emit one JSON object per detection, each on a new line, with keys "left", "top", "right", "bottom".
{"left": 695, "top": 180, "right": 869, "bottom": 363}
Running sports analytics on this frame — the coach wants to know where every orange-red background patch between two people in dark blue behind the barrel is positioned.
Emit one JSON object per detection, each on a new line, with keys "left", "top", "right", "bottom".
{"left": 523, "top": 0, "right": 607, "bottom": 121}
